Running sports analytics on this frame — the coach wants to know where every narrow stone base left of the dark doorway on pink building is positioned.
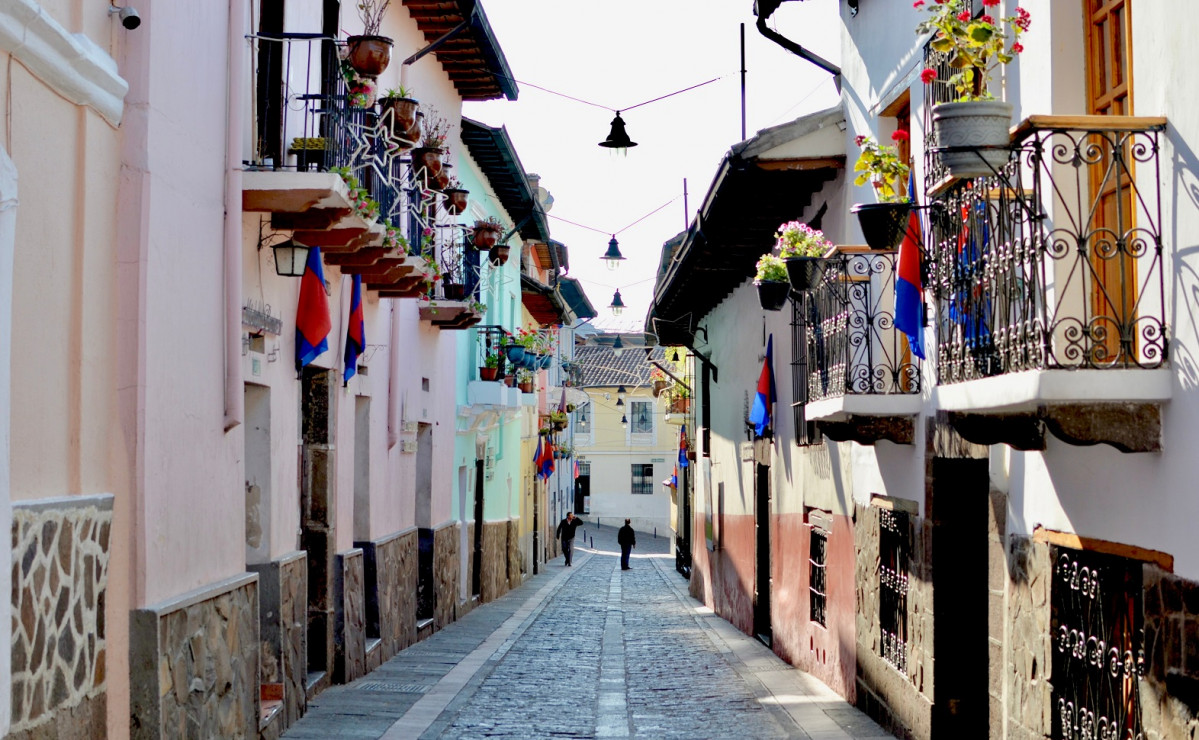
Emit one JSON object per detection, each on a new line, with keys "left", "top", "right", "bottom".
{"left": 249, "top": 551, "right": 308, "bottom": 732}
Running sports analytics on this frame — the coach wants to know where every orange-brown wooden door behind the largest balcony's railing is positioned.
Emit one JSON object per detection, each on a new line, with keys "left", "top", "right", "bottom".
{"left": 1084, "top": 0, "right": 1138, "bottom": 367}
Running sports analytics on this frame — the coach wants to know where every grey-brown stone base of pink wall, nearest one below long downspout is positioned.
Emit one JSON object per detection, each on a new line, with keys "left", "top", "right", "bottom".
{"left": 129, "top": 573, "right": 260, "bottom": 740}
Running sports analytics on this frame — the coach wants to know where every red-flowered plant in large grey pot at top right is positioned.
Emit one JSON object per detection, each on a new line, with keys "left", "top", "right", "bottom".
{"left": 915, "top": 0, "right": 1031, "bottom": 178}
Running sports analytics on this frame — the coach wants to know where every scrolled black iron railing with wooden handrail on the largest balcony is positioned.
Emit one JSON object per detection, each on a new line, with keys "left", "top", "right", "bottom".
{"left": 926, "top": 116, "right": 1168, "bottom": 384}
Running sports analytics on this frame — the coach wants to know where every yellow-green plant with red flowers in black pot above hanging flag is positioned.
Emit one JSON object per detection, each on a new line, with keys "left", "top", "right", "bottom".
{"left": 850, "top": 128, "right": 911, "bottom": 251}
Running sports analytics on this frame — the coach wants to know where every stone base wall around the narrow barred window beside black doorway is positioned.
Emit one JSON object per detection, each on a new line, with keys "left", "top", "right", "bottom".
{"left": 854, "top": 504, "right": 933, "bottom": 740}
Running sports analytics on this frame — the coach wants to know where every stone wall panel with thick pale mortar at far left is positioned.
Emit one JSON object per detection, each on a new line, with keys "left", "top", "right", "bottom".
{"left": 5, "top": 494, "right": 113, "bottom": 739}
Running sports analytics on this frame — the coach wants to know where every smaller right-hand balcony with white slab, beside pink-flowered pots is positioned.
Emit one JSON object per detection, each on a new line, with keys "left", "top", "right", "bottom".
{"left": 797, "top": 247, "right": 922, "bottom": 445}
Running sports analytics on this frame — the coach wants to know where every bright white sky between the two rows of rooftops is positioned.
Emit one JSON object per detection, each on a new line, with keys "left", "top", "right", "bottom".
{"left": 463, "top": 0, "right": 839, "bottom": 331}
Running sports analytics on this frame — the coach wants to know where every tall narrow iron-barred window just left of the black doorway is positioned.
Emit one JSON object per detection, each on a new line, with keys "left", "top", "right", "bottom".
{"left": 879, "top": 509, "right": 911, "bottom": 673}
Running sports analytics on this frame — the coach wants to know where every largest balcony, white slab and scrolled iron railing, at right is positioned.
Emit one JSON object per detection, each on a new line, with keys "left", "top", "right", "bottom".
{"left": 926, "top": 116, "right": 1171, "bottom": 452}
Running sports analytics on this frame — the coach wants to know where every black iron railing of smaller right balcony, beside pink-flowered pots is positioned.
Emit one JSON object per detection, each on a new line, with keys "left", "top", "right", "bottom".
{"left": 800, "top": 247, "right": 921, "bottom": 402}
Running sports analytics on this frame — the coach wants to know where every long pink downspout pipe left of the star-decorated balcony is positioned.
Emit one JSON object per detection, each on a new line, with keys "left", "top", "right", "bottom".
{"left": 224, "top": 0, "right": 248, "bottom": 432}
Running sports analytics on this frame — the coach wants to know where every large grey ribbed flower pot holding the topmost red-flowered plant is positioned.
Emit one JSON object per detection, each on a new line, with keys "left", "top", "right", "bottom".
{"left": 933, "top": 101, "right": 1012, "bottom": 180}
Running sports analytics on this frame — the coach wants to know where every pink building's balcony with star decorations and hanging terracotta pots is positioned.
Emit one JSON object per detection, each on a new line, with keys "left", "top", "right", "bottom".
{"left": 242, "top": 34, "right": 467, "bottom": 289}
